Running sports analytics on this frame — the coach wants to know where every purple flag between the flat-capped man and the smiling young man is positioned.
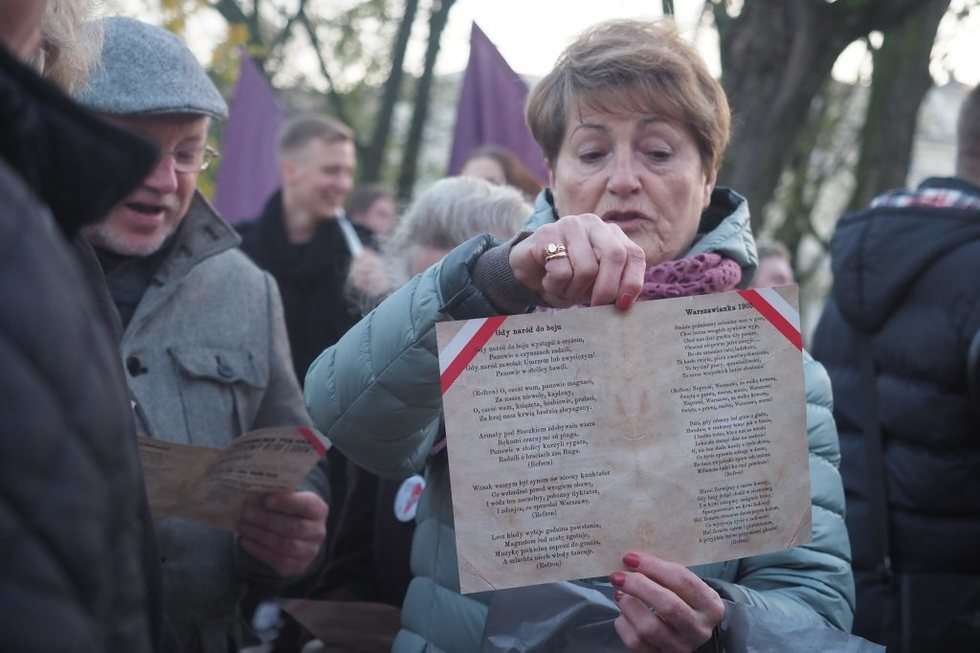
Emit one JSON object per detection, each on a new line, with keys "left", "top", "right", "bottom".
{"left": 214, "top": 52, "right": 286, "bottom": 223}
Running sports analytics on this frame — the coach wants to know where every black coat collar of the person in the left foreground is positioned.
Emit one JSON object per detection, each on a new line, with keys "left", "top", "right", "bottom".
{"left": 0, "top": 47, "right": 157, "bottom": 238}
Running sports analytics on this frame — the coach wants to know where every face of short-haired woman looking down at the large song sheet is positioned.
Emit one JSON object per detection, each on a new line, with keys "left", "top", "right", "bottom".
{"left": 551, "top": 107, "right": 715, "bottom": 266}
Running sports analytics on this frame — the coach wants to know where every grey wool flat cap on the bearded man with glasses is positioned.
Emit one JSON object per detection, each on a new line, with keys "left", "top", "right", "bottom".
{"left": 77, "top": 16, "right": 228, "bottom": 118}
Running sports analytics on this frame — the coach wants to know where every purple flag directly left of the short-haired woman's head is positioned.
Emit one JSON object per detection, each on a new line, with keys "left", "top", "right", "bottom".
{"left": 449, "top": 23, "right": 548, "bottom": 181}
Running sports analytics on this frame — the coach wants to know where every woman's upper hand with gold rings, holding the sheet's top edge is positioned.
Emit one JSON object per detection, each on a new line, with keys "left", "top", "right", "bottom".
{"left": 510, "top": 213, "right": 646, "bottom": 310}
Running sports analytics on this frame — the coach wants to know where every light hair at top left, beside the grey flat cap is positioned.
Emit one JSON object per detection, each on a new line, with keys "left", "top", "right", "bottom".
{"left": 38, "top": 0, "right": 102, "bottom": 93}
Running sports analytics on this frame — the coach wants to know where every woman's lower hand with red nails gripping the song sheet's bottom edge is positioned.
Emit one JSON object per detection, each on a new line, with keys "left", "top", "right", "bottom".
{"left": 609, "top": 553, "right": 725, "bottom": 653}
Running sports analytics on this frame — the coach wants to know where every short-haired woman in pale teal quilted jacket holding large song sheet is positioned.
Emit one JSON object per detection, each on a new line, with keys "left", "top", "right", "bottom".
{"left": 306, "top": 21, "right": 853, "bottom": 653}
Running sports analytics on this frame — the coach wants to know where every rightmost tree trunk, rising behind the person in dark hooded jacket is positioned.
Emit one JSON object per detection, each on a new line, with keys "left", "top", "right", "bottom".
{"left": 848, "top": 0, "right": 950, "bottom": 211}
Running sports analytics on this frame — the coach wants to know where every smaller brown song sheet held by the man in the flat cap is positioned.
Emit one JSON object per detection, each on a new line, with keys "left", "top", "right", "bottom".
{"left": 139, "top": 427, "right": 329, "bottom": 530}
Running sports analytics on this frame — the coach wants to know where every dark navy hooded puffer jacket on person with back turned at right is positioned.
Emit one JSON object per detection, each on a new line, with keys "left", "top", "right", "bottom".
{"left": 812, "top": 178, "right": 980, "bottom": 640}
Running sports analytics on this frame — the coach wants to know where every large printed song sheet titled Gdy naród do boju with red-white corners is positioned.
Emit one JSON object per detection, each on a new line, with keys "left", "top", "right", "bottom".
{"left": 437, "top": 286, "right": 810, "bottom": 593}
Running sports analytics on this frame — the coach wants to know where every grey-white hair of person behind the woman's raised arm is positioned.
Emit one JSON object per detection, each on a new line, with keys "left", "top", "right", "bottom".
{"left": 352, "top": 177, "right": 531, "bottom": 313}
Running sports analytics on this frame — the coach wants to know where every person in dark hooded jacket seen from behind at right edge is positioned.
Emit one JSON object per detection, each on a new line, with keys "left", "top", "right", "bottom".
{"left": 813, "top": 87, "right": 980, "bottom": 652}
